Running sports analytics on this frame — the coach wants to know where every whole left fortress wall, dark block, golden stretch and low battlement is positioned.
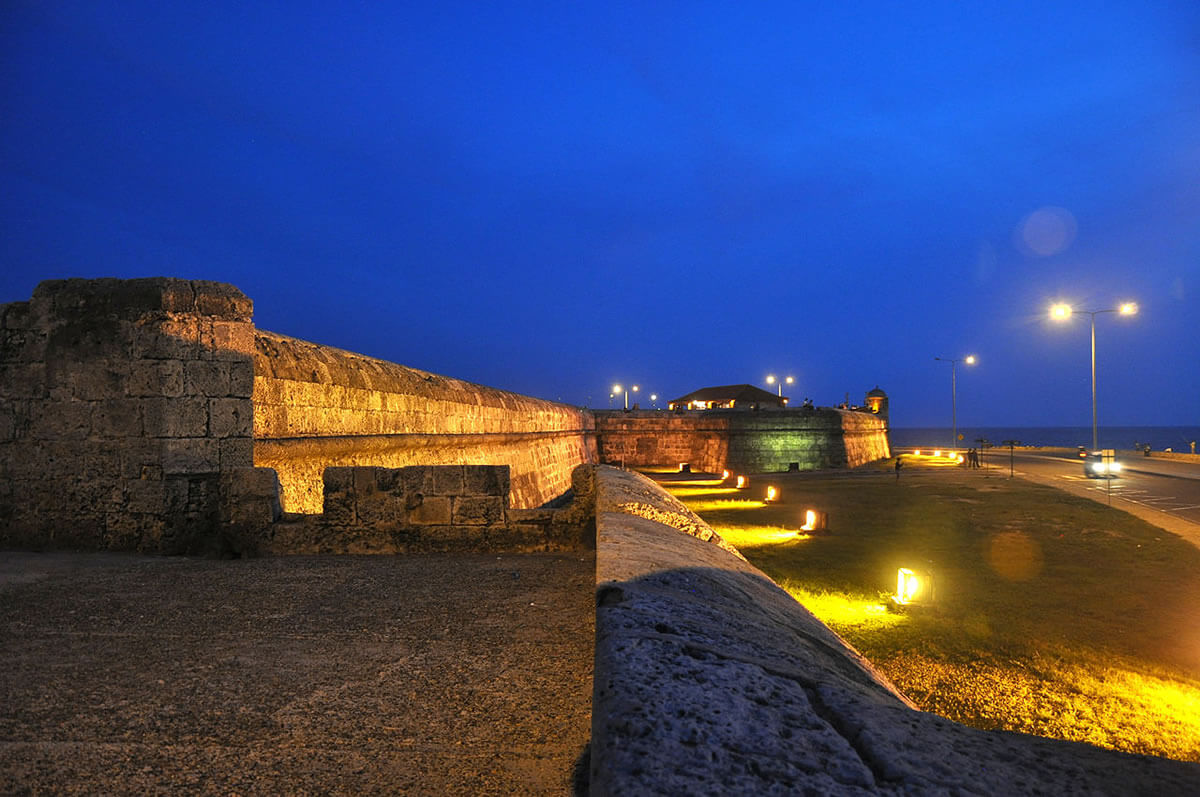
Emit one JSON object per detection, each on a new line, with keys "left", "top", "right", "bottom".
{"left": 0, "top": 277, "right": 595, "bottom": 553}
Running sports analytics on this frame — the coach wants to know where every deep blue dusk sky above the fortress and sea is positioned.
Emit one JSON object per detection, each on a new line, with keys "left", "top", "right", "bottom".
{"left": 0, "top": 0, "right": 1200, "bottom": 426}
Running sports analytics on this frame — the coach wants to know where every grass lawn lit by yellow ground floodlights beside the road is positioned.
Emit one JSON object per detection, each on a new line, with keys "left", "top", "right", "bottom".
{"left": 653, "top": 463, "right": 1200, "bottom": 761}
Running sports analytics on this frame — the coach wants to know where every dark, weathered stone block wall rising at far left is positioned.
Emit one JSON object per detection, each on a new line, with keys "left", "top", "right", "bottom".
{"left": 0, "top": 278, "right": 254, "bottom": 553}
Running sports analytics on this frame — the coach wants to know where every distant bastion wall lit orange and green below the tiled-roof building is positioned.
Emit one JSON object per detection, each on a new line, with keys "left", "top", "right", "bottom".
{"left": 594, "top": 408, "right": 890, "bottom": 473}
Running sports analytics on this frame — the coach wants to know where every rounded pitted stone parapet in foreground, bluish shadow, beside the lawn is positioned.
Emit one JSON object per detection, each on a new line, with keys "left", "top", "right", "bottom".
{"left": 590, "top": 466, "right": 1200, "bottom": 796}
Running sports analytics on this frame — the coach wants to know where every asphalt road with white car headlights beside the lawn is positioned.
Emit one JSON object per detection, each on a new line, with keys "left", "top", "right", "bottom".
{"left": 988, "top": 449, "right": 1200, "bottom": 525}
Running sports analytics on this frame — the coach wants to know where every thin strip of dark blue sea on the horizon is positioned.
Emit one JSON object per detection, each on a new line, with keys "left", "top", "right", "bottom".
{"left": 892, "top": 426, "right": 1200, "bottom": 453}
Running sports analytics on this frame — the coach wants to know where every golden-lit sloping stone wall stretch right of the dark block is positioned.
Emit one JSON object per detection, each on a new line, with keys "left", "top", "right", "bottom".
{"left": 253, "top": 330, "right": 596, "bottom": 513}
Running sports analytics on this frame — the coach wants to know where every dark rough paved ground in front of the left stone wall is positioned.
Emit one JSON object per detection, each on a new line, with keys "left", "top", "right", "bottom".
{"left": 0, "top": 553, "right": 595, "bottom": 795}
